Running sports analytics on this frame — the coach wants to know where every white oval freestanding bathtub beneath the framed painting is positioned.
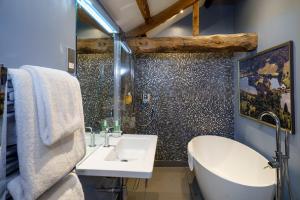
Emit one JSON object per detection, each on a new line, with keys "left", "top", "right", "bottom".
{"left": 188, "top": 136, "right": 276, "bottom": 200}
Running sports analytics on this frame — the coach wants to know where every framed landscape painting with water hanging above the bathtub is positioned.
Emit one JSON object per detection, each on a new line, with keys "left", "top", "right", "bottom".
{"left": 239, "top": 41, "right": 295, "bottom": 133}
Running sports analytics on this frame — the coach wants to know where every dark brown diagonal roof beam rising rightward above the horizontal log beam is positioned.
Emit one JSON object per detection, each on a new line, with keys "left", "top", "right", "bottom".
{"left": 126, "top": 0, "right": 203, "bottom": 37}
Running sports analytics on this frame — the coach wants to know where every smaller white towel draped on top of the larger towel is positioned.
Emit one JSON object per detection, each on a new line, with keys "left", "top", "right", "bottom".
{"left": 21, "top": 65, "right": 84, "bottom": 145}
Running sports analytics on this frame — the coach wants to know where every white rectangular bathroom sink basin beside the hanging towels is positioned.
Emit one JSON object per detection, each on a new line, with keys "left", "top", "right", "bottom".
{"left": 76, "top": 134, "right": 157, "bottom": 178}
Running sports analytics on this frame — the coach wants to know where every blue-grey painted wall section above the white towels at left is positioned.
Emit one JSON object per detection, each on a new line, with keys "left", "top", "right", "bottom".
{"left": 0, "top": 0, "right": 76, "bottom": 70}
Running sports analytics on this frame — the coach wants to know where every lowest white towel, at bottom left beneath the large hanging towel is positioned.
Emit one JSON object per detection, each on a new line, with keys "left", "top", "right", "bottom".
{"left": 38, "top": 173, "right": 84, "bottom": 200}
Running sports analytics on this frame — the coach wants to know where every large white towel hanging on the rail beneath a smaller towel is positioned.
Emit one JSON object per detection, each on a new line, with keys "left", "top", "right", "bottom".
{"left": 8, "top": 69, "right": 85, "bottom": 200}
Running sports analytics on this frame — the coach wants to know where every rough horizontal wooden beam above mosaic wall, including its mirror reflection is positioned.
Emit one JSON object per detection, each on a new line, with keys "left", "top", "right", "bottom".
{"left": 77, "top": 33, "right": 258, "bottom": 54}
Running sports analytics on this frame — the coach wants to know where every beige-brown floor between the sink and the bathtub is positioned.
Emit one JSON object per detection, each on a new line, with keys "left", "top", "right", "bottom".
{"left": 127, "top": 167, "right": 193, "bottom": 200}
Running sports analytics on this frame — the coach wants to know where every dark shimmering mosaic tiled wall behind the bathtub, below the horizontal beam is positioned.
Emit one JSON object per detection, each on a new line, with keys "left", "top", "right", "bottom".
{"left": 135, "top": 53, "right": 234, "bottom": 161}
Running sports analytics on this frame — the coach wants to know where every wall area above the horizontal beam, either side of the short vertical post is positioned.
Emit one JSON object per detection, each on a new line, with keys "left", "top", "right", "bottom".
{"left": 156, "top": 5, "right": 235, "bottom": 37}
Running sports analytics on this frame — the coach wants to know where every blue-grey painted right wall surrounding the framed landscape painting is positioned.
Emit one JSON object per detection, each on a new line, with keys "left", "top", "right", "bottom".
{"left": 235, "top": 0, "right": 300, "bottom": 199}
